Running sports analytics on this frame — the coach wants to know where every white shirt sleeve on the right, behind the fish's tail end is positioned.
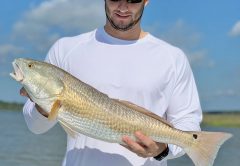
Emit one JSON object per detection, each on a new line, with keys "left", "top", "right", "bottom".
{"left": 165, "top": 52, "right": 202, "bottom": 160}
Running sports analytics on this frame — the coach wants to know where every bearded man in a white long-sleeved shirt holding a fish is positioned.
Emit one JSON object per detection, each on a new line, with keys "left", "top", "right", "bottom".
{"left": 21, "top": 0, "right": 202, "bottom": 166}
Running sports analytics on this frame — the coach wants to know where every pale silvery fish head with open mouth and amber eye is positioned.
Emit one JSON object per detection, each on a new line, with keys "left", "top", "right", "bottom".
{"left": 10, "top": 58, "right": 64, "bottom": 107}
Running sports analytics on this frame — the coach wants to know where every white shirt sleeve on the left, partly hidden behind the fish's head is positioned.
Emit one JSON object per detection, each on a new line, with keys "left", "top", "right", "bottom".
{"left": 23, "top": 39, "right": 60, "bottom": 134}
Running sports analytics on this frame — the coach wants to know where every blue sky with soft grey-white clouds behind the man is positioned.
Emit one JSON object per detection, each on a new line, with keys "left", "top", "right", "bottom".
{"left": 0, "top": 0, "right": 240, "bottom": 111}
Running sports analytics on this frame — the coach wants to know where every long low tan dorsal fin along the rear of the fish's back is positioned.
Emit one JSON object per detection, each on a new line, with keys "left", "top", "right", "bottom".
{"left": 113, "top": 99, "right": 173, "bottom": 127}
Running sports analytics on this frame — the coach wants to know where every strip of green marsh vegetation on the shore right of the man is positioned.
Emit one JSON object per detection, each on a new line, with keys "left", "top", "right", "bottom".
{"left": 202, "top": 111, "right": 240, "bottom": 128}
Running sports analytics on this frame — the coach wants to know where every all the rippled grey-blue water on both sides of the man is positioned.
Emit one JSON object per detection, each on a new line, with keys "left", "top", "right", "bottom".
{"left": 0, "top": 110, "right": 240, "bottom": 166}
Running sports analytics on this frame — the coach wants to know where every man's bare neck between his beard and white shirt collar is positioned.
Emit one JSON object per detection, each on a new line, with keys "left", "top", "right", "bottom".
{"left": 104, "top": 24, "right": 147, "bottom": 40}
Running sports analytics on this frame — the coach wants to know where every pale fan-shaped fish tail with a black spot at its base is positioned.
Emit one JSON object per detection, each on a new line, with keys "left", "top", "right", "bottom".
{"left": 184, "top": 132, "right": 232, "bottom": 166}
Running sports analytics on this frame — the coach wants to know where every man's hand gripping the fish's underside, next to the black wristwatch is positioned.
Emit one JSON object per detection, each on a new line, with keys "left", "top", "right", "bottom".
{"left": 122, "top": 131, "right": 167, "bottom": 158}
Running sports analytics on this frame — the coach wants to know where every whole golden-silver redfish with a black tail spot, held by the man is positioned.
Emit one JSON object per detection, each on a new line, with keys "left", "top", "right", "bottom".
{"left": 10, "top": 58, "right": 232, "bottom": 166}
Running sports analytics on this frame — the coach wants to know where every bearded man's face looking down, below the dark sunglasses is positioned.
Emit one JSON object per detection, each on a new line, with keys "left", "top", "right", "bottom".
{"left": 105, "top": 0, "right": 145, "bottom": 31}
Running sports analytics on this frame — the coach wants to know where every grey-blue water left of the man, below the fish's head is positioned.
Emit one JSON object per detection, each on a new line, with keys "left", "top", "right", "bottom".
{"left": 0, "top": 110, "right": 66, "bottom": 166}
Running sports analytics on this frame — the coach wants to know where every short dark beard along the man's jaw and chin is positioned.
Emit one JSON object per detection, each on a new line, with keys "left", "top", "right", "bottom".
{"left": 105, "top": 3, "right": 144, "bottom": 31}
